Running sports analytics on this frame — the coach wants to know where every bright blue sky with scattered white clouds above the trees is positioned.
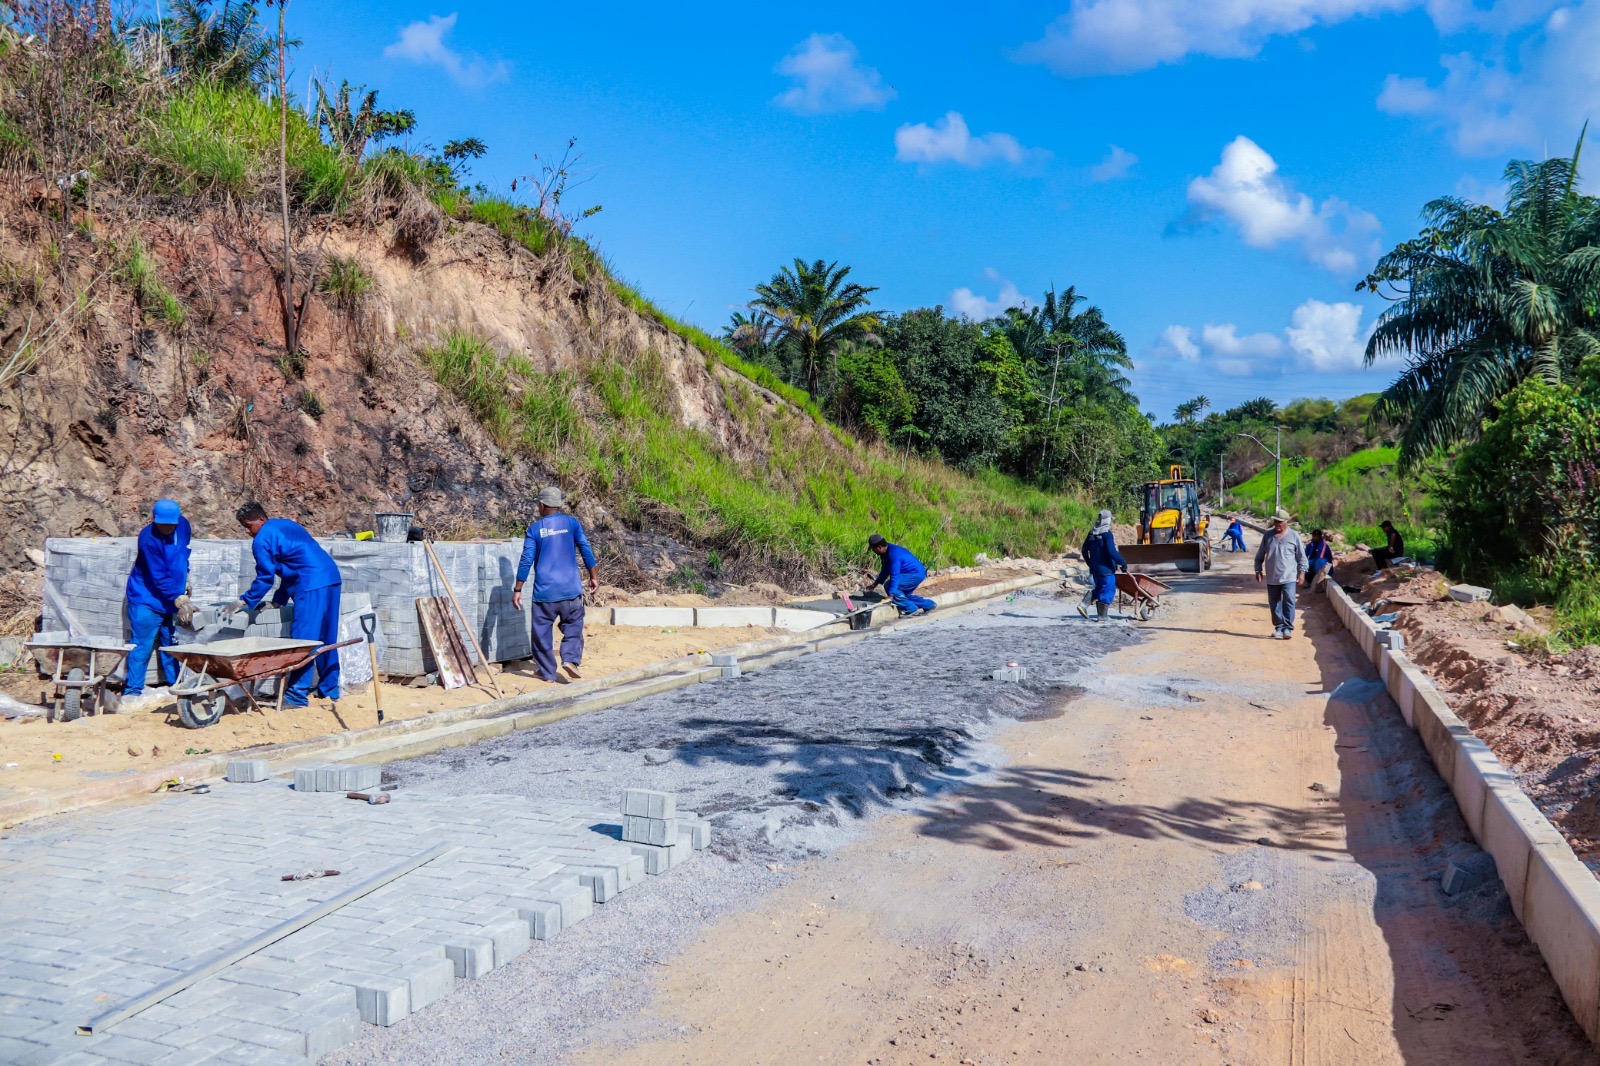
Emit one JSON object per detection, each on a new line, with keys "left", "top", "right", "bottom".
{"left": 278, "top": 0, "right": 1600, "bottom": 418}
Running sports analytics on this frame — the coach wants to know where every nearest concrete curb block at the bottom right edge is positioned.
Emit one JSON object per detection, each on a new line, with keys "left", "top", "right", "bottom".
{"left": 1522, "top": 840, "right": 1600, "bottom": 1040}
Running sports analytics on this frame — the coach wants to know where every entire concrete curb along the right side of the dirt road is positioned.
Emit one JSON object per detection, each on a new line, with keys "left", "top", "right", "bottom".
{"left": 1325, "top": 583, "right": 1600, "bottom": 1042}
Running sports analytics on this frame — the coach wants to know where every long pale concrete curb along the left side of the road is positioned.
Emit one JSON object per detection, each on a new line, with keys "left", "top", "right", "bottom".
{"left": 0, "top": 575, "right": 1056, "bottom": 828}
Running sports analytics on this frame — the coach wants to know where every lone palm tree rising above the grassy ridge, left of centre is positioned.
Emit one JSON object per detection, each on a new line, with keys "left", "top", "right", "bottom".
{"left": 750, "top": 258, "right": 878, "bottom": 397}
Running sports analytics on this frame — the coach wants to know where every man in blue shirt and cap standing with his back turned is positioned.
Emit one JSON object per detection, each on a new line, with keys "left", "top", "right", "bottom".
{"left": 510, "top": 485, "right": 600, "bottom": 683}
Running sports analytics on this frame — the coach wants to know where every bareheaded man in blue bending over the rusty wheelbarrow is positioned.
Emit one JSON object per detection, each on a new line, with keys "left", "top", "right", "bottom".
{"left": 227, "top": 503, "right": 342, "bottom": 707}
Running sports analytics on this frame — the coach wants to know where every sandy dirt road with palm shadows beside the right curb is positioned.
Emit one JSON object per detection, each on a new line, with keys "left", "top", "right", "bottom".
{"left": 581, "top": 557, "right": 1597, "bottom": 1066}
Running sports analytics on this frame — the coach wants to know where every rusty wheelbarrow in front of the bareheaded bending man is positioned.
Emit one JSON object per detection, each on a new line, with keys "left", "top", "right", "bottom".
{"left": 162, "top": 637, "right": 363, "bottom": 730}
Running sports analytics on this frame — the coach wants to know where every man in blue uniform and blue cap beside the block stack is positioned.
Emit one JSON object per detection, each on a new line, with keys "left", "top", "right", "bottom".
{"left": 122, "top": 499, "right": 194, "bottom": 698}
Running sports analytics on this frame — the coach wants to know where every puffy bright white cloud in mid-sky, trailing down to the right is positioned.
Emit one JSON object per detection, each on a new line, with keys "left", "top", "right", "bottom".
{"left": 1189, "top": 136, "right": 1378, "bottom": 274}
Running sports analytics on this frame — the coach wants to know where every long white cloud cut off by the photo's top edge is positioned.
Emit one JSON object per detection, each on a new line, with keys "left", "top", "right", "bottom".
{"left": 1016, "top": 0, "right": 1418, "bottom": 77}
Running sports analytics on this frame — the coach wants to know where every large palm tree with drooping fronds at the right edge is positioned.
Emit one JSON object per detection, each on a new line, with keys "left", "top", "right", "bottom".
{"left": 1362, "top": 136, "right": 1600, "bottom": 467}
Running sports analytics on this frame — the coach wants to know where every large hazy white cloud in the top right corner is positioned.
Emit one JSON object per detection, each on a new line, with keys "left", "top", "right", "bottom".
{"left": 1378, "top": 0, "right": 1600, "bottom": 155}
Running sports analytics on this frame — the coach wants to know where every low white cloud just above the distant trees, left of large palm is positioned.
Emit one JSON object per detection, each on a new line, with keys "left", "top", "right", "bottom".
{"left": 1152, "top": 299, "right": 1376, "bottom": 378}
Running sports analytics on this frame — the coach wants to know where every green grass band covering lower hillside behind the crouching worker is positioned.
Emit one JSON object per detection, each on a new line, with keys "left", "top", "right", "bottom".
{"left": 422, "top": 333, "right": 1091, "bottom": 575}
